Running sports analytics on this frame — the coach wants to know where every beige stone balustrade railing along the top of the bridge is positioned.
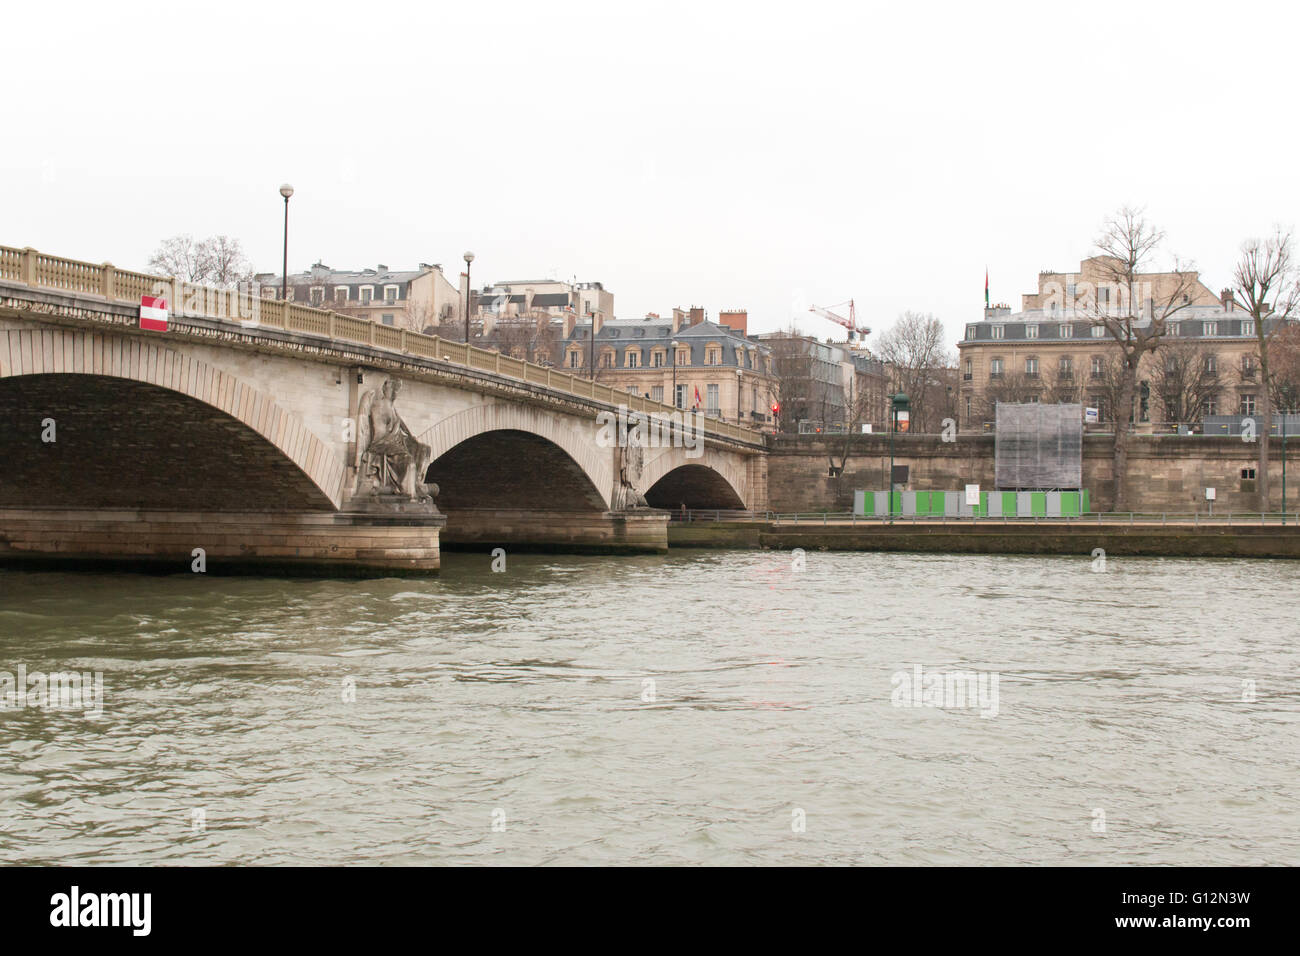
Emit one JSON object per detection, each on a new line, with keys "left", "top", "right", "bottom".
{"left": 0, "top": 246, "right": 763, "bottom": 444}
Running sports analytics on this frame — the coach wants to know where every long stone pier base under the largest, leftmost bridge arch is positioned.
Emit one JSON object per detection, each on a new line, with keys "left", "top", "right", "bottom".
{"left": 0, "top": 509, "right": 446, "bottom": 578}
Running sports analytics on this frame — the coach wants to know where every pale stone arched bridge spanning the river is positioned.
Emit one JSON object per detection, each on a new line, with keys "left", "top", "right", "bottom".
{"left": 0, "top": 246, "right": 766, "bottom": 574}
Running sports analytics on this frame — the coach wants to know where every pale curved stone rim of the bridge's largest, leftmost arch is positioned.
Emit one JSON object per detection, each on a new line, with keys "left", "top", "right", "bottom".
{"left": 0, "top": 328, "right": 345, "bottom": 510}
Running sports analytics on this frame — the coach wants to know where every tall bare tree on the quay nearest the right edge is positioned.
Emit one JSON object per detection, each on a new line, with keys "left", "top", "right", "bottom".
{"left": 1232, "top": 228, "right": 1300, "bottom": 512}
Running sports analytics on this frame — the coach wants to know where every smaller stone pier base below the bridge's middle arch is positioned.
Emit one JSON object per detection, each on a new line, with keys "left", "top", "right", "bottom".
{"left": 442, "top": 509, "right": 668, "bottom": 554}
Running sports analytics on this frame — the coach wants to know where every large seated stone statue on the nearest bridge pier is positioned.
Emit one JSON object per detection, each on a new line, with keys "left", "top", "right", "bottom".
{"left": 352, "top": 378, "right": 437, "bottom": 501}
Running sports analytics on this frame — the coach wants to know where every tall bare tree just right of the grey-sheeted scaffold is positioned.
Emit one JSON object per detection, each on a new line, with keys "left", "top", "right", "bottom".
{"left": 1086, "top": 206, "right": 1195, "bottom": 511}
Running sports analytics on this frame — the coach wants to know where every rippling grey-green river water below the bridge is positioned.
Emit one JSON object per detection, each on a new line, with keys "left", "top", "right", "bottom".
{"left": 0, "top": 551, "right": 1300, "bottom": 865}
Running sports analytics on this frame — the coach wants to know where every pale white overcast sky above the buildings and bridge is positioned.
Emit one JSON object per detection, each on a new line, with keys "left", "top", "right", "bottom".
{"left": 0, "top": 0, "right": 1300, "bottom": 345}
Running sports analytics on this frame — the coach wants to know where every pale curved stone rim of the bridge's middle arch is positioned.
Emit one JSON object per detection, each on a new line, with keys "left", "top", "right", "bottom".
{"left": 419, "top": 402, "right": 614, "bottom": 510}
